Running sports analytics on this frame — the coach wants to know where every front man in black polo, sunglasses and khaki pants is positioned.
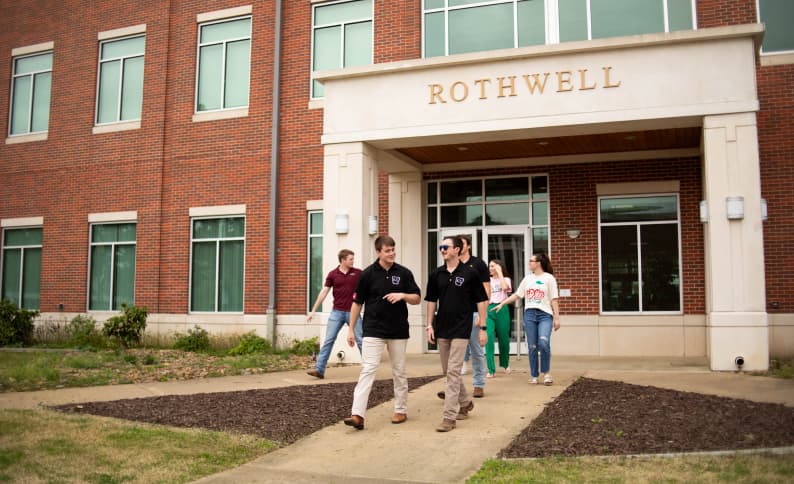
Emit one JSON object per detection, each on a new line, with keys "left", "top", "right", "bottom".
{"left": 425, "top": 237, "right": 488, "bottom": 432}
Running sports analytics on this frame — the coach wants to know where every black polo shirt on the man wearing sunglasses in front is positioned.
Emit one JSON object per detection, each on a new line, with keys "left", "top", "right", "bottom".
{"left": 425, "top": 263, "right": 488, "bottom": 339}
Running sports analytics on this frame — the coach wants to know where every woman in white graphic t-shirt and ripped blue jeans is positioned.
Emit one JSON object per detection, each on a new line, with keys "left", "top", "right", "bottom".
{"left": 491, "top": 252, "right": 560, "bottom": 385}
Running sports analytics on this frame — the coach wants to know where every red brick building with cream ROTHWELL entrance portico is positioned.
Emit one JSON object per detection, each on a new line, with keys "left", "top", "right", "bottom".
{"left": 0, "top": 0, "right": 794, "bottom": 369}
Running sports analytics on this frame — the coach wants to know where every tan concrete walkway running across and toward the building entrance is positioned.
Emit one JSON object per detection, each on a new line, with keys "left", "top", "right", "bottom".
{"left": 0, "top": 355, "right": 794, "bottom": 483}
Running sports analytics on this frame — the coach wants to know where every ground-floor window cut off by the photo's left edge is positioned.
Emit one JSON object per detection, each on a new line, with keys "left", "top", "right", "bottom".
{"left": 0, "top": 227, "right": 42, "bottom": 309}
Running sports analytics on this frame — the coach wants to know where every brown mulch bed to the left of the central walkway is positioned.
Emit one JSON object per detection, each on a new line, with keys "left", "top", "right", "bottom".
{"left": 53, "top": 375, "right": 441, "bottom": 444}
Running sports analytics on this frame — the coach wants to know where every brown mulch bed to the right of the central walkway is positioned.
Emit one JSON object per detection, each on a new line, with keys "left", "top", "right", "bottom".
{"left": 499, "top": 378, "right": 794, "bottom": 458}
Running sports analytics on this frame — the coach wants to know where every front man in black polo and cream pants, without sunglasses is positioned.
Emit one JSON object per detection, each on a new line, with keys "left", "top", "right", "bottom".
{"left": 345, "top": 235, "right": 421, "bottom": 430}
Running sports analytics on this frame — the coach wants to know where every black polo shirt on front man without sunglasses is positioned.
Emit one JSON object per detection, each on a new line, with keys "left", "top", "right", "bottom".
{"left": 354, "top": 260, "right": 421, "bottom": 339}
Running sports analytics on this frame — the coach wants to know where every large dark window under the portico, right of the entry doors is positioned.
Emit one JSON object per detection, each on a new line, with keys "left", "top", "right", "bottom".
{"left": 599, "top": 195, "right": 681, "bottom": 312}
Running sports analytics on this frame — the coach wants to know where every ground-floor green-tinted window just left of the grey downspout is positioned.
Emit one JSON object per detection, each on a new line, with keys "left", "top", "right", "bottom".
{"left": 190, "top": 217, "right": 245, "bottom": 312}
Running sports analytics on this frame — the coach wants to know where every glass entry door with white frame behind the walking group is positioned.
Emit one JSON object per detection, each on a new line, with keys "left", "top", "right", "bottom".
{"left": 483, "top": 227, "right": 530, "bottom": 354}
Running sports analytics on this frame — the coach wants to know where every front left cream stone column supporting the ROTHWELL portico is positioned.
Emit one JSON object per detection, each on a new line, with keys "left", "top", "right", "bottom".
{"left": 324, "top": 143, "right": 378, "bottom": 276}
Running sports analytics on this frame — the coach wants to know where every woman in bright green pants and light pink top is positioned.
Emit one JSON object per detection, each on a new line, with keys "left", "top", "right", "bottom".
{"left": 485, "top": 259, "right": 513, "bottom": 378}
